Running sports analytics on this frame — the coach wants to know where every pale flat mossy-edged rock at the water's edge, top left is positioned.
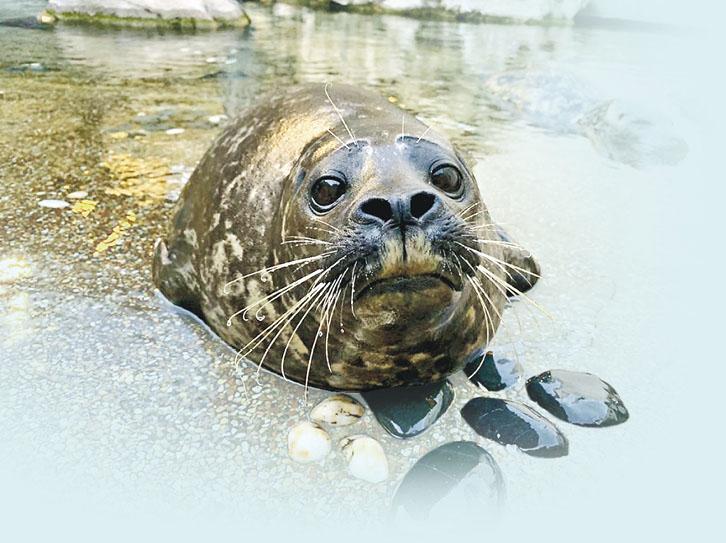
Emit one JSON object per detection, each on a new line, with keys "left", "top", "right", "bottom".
{"left": 41, "top": 0, "right": 250, "bottom": 28}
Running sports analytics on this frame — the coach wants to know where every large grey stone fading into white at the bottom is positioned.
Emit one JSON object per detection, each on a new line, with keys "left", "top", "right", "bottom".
{"left": 392, "top": 441, "right": 504, "bottom": 519}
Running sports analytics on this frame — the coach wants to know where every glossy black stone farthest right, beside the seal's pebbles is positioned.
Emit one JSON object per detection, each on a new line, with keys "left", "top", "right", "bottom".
{"left": 527, "top": 370, "right": 629, "bottom": 426}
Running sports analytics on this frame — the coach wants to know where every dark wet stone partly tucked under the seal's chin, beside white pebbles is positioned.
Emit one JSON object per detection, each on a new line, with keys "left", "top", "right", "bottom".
{"left": 362, "top": 380, "right": 454, "bottom": 438}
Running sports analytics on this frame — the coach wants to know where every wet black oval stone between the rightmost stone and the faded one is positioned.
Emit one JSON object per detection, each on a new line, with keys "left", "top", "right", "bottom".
{"left": 461, "top": 398, "right": 568, "bottom": 458}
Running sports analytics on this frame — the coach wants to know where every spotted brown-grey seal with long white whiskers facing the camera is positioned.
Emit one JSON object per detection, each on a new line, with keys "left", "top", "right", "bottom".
{"left": 153, "top": 85, "right": 537, "bottom": 391}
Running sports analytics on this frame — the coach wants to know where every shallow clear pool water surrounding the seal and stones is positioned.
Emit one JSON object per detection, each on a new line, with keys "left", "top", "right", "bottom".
{"left": 0, "top": 1, "right": 719, "bottom": 540}
